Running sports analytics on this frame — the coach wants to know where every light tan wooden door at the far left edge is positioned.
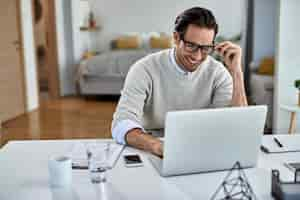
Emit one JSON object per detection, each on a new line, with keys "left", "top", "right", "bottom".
{"left": 0, "top": 0, "right": 25, "bottom": 121}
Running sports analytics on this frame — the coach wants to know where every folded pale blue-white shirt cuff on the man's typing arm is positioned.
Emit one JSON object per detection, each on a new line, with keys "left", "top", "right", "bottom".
{"left": 112, "top": 119, "right": 144, "bottom": 145}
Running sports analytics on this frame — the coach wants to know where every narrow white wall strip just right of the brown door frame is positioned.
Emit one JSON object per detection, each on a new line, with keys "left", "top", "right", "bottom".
{"left": 55, "top": 0, "right": 76, "bottom": 96}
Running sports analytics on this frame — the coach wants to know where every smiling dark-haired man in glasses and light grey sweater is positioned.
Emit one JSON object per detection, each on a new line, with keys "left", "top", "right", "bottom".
{"left": 112, "top": 7, "right": 247, "bottom": 156}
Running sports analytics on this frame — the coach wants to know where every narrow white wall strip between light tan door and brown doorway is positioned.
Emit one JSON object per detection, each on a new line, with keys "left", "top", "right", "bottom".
{"left": 21, "top": 0, "right": 39, "bottom": 111}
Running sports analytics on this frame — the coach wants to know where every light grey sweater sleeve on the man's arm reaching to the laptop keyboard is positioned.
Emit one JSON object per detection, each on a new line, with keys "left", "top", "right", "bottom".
{"left": 111, "top": 60, "right": 152, "bottom": 143}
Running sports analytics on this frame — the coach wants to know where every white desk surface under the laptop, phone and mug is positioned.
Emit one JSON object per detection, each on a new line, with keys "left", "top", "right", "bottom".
{"left": 0, "top": 136, "right": 300, "bottom": 200}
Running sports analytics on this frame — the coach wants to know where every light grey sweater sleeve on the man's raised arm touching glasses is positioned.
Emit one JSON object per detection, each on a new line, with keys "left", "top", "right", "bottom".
{"left": 211, "top": 66, "right": 233, "bottom": 108}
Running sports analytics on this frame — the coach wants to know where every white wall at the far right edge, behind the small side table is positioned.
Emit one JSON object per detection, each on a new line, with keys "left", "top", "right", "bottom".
{"left": 274, "top": 0, "right": 300, "bottom": 133}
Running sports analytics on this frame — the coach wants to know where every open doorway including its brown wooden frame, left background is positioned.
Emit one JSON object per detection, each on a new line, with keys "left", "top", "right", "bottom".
{"left": 32, "top": 0, "right": 60, "bottom": 98}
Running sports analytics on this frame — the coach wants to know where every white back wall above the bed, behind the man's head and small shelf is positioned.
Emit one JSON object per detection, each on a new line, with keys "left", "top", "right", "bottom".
{"left": 63, "top": 0, "right": 246, "bottom": 95}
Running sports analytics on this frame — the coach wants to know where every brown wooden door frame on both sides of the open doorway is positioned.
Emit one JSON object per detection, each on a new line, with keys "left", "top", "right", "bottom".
{"left": 31, "top": 0, "right": 60, "bottom": 99}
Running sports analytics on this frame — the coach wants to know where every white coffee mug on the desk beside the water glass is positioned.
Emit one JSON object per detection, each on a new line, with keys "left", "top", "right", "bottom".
{"left": 48, "top": 156, "right": 72, "bottom": 187}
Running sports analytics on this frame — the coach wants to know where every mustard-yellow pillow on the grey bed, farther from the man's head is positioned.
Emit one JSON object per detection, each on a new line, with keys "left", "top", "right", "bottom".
{"left": 115, "top": 35, "right": 141, "bottom": 49}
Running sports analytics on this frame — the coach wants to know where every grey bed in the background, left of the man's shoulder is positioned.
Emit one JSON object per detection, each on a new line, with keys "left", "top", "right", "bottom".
{"left": 76, "top": 49, "right": 160, "bottom": 96}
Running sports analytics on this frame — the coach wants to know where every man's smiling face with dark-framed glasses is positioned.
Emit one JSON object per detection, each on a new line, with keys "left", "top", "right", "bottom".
{"left": 174, "top": 24, "right": 215, "bottom": 72}
